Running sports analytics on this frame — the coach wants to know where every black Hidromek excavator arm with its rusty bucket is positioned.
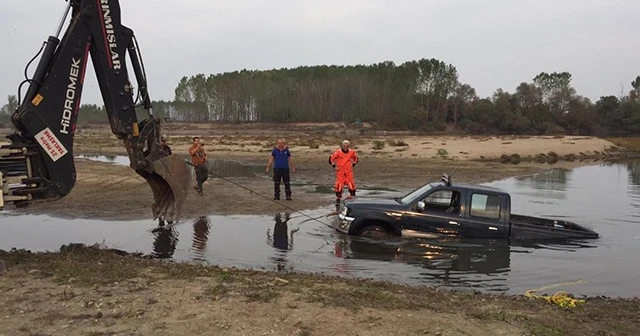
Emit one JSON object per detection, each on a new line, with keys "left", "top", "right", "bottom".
{"left": 0, "top": 0, "right": 191, "bottom": 222}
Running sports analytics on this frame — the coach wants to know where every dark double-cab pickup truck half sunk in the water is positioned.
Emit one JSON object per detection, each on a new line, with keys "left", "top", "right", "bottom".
{"left": 333, "top": 174, "right": 599, "bottom": 240}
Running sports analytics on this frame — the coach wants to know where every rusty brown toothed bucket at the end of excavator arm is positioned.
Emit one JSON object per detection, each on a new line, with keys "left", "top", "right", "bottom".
{"left": 144, "top": 155, "right": 192, "bottom": 222}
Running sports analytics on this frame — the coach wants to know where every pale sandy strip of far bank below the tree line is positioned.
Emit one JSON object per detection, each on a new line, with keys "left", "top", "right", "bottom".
{"left": 70, "top": 123, "right": 614, "bottom": 160}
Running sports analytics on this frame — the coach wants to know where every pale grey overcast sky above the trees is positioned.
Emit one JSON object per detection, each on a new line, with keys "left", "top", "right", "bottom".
{"left": 0, "top": 0, "right": 640, "bottom": 105}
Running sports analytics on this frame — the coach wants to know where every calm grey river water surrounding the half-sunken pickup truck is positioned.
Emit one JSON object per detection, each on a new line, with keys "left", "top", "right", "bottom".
{"left": 0, "top": 162, "right": 640, "bottom": 297}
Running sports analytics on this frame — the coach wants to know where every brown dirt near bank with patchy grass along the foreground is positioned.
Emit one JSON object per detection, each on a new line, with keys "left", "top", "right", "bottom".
{"left": 0, "top": 248, "right": 640, "bottom": 336}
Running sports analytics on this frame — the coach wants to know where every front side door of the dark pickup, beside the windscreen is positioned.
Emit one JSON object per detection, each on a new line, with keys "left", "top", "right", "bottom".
{"left": 403, "top": 188, "right": 461, "bottom": 235}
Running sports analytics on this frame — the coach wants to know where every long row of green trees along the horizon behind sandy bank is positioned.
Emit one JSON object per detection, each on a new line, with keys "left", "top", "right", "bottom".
{"left": 0, "top": 58, "right": 640, "bottom": 136}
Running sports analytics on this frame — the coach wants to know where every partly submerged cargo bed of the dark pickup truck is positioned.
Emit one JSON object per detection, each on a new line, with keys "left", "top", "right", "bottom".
{"left": 510, "top": 214, "right": 599, "bottom": 239}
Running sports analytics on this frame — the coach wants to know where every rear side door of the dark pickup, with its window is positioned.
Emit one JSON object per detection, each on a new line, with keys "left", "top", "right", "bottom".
{"left": 459, "top": 190, "right": 509, "bottom": 238}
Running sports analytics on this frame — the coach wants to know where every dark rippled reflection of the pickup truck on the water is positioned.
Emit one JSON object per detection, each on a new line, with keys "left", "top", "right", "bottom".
{"left": 332, "top": 236, "right": 596, "bottom": 292}
